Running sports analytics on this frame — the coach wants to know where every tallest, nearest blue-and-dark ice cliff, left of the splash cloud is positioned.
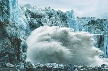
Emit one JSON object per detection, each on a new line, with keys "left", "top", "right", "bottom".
{"left": 0, "top": 0, "right": 29, "bottom": 64}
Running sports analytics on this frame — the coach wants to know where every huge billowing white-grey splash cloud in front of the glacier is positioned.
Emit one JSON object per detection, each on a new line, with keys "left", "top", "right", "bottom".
{"left": 26, "top": 26, "right": 105, "bottom": 66}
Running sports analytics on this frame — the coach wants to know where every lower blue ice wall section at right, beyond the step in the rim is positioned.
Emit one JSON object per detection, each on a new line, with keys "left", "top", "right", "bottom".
{"left": 76, "top": 17, "right": 108, "bottom": 57}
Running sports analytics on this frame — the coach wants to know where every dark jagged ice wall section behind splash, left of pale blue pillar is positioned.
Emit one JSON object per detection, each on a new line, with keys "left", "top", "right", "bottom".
{"left": 21, "top": 4, "right": 68, "bottom": 30}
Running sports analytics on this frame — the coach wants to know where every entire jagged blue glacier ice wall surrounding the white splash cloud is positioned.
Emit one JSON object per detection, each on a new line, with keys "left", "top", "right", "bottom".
{"left": 0, "top": 0, "right": 108, "bottom": 64}
